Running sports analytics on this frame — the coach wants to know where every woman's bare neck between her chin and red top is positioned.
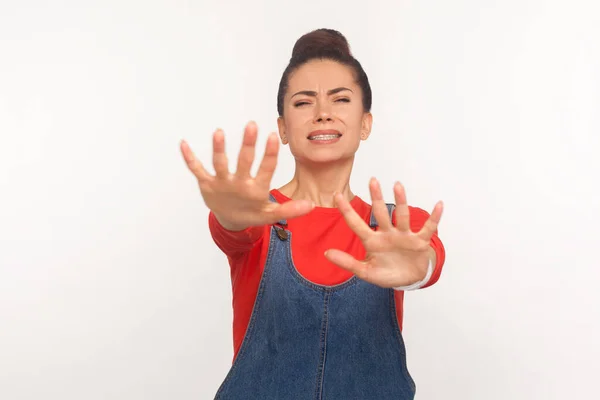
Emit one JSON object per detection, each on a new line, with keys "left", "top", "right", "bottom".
{"left": 279, "top": 160, "right": 354, "bottom": 207}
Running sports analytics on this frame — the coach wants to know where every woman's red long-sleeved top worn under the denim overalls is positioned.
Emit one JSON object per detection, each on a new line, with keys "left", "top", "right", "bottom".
{"left": 208, "top": 189, "right": 445, "bottom": 359}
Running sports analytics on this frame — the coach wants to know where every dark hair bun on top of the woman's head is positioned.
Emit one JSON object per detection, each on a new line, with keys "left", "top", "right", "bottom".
{"left": 292, "top": 28, "right": 352, "bottom": 59}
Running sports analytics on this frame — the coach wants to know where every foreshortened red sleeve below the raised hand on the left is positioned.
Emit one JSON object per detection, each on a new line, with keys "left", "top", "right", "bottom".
{"left": 208, "top": 211, "right": 265, "bottom": 258}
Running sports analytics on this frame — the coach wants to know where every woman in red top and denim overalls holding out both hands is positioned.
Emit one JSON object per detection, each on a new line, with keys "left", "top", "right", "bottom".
{"left": 181, "top": 29, "right": 444, "bottom": 400}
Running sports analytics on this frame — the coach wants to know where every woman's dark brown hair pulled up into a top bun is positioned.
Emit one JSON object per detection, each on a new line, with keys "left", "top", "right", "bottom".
{"left": 277, "top": 28, "right": 372, "bottom": 116}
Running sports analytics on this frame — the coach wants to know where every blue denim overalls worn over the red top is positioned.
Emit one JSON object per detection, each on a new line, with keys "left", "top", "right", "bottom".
{"left": 215, "top": 196, "right": 415, "bottom": 400}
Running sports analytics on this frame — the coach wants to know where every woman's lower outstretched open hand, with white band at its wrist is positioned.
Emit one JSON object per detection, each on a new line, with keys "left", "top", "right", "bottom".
{"left": 325, "top": 178, "right": 443, "bottom": 288}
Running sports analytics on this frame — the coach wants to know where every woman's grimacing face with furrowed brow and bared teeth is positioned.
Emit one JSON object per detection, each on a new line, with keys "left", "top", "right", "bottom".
{"left": 278, "top": 60, "right": 372, "bottom": 163}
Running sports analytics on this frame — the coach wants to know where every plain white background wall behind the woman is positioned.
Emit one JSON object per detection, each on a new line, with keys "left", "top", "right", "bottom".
{"left": 0, "top": 0, "right": 600, "bottom": 400}
